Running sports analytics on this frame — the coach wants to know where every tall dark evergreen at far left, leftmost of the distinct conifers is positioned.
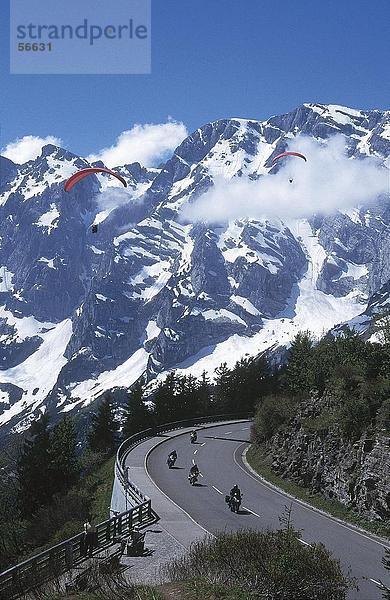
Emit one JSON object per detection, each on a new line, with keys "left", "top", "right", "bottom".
{"left": 17, "top": 415, "right": 51, "bottom": 517}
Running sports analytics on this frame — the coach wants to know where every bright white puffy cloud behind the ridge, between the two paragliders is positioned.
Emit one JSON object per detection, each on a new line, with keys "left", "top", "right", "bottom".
{"left": 87, "top": 120, "right": 188, "bottom": 167}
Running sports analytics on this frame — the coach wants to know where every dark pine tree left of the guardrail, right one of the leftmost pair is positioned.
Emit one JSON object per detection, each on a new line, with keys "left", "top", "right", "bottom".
{"left": 49, "top": 417, "right": 80, "bottom": 493}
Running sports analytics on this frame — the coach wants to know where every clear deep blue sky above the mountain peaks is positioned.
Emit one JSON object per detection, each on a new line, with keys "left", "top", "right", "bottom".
{"left": 0, "top": 0, "right": 390, "bottom": 162}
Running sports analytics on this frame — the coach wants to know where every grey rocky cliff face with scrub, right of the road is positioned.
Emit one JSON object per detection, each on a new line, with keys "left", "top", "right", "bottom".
{"left": 267, "top": 395, "right": 390, "bottom": 521}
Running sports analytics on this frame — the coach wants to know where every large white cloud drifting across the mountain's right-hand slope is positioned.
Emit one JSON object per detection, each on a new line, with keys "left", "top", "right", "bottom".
{"left": 182, "top": 136, "right": 390, "bottom": 223}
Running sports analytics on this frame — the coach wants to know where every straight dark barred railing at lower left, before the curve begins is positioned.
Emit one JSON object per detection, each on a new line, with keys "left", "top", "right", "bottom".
{"left": 0, "top": 500, "right": 152, "bottom": 600}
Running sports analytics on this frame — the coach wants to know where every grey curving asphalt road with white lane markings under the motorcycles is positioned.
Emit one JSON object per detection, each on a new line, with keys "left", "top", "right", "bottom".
{"left": 145, "top": 422, "right": 388, "bottom": 600}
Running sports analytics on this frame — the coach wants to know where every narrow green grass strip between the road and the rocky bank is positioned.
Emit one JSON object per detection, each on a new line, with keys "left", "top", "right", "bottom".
{"left": 246, "top": 444, "right": 390, "bottom": 539}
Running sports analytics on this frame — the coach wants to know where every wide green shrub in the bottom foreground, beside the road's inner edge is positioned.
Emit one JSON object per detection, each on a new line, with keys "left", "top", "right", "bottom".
{"left": 163, "top": 526, "right": 354, "bottom": 600}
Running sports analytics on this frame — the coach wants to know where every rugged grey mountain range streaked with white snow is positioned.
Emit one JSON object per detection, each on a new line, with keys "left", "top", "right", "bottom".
{"left": 0, "top": 104, "right": 390, "bottom": 435}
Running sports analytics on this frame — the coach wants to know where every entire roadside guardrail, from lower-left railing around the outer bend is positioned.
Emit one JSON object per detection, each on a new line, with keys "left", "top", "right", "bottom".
{"left": 0, "top": 413, "right": 252, "bottom": 600}
